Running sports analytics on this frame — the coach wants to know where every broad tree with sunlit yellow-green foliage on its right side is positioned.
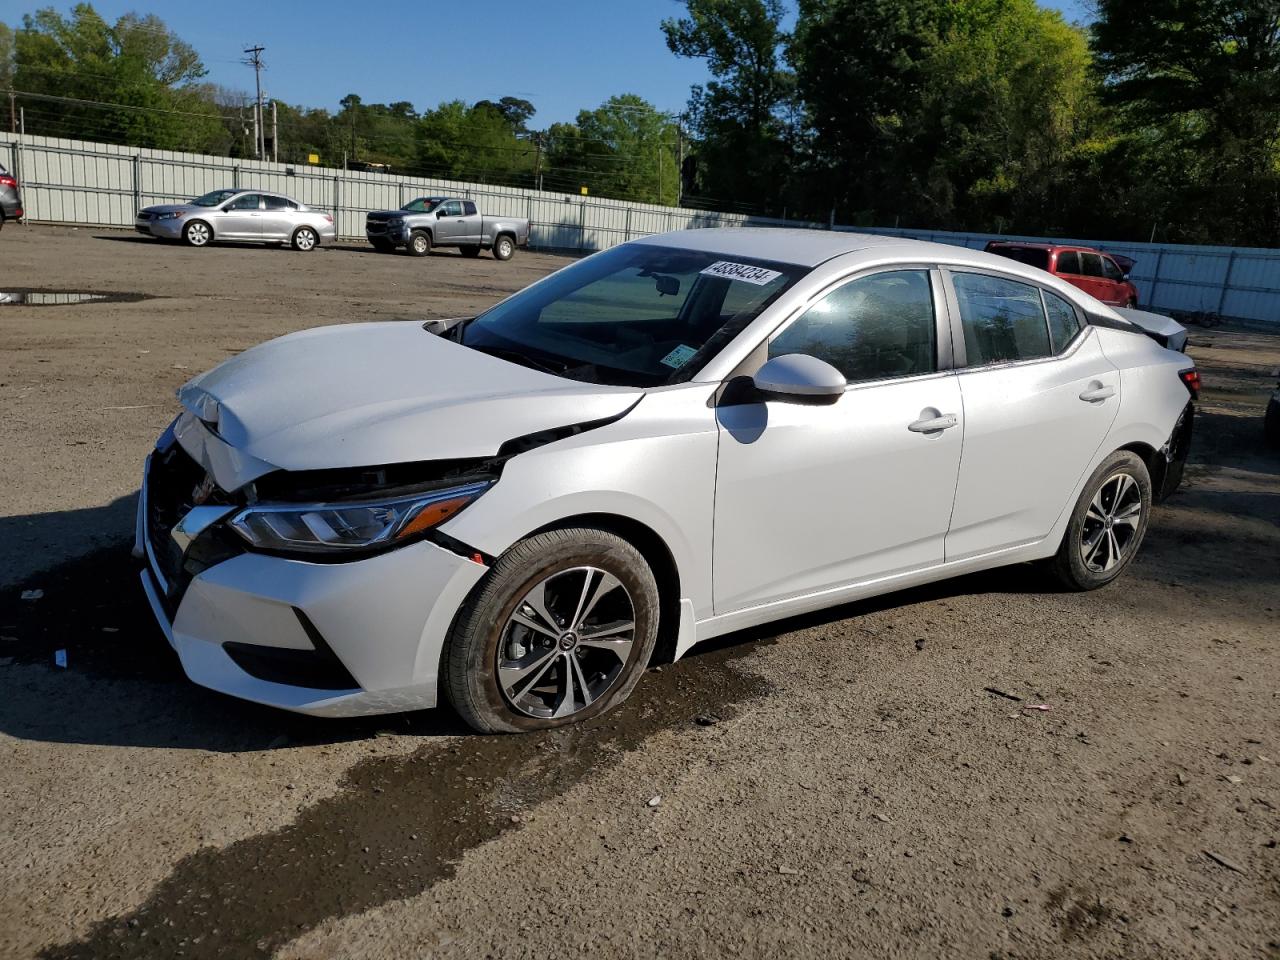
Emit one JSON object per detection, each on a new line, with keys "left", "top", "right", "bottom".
{"left": 790, "top": 0, "right": 1094, "bottom": 230}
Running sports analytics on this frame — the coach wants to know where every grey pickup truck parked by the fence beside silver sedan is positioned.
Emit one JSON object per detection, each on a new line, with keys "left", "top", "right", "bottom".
{"left": 365, "top": 197, "right": 529, "bottom": 260}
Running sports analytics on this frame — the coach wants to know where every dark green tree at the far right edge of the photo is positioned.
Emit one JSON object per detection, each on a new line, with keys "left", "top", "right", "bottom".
{"left": 1092, "top": 0, "right": 1280, "bottom": 246}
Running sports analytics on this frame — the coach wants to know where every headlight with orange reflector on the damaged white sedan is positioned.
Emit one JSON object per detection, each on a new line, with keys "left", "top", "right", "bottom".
{"left": 230, "top": 481, "right": 493, "bottom": 553}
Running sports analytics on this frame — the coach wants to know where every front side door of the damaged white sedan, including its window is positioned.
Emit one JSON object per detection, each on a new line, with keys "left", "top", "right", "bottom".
{"left": 714, "top": 268, "right": 964, "bottom": 614}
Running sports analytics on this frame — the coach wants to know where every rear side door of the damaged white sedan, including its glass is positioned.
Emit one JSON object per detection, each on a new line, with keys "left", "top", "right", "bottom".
{"left": 946, "top": 269, "right": 1120, "bottom": 562}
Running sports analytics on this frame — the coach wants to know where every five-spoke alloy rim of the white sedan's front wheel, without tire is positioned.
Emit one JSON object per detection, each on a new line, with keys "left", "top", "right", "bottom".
{"left": 495, "top": 567, "right": 636, "bottom": 718}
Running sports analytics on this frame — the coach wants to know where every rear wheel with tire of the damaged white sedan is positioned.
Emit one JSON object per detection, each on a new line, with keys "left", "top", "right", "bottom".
{"left": 1052, "top": 451, "right": 1152, "bottom": 590}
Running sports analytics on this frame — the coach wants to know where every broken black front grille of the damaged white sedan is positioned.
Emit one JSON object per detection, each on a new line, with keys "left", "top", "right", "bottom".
{"left": 145, "top": 443, "right": 242, "bottom": 616}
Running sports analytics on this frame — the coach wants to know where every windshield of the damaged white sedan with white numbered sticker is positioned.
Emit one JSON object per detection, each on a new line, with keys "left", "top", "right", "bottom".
{"left": 451, "top": 243, "right": 808, "bottom": 387}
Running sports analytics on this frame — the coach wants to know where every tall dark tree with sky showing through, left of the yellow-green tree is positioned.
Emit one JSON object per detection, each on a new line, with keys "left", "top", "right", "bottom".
{"left": 662, "top": 0, "right": 795, "bottom": 207}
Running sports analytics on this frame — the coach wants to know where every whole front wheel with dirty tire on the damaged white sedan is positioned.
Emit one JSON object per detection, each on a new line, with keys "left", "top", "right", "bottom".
{"left": 440, "top": 527, "right": 659, "bottom": 733}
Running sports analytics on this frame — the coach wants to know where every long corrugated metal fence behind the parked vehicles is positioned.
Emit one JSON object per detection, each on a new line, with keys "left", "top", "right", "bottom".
{"left": 0, "top": 132, "right": 1280, "bottom": 324}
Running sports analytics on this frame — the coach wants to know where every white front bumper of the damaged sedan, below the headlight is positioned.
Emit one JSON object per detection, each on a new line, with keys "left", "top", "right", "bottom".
{"left": 134, "top": 458, "right": 486, "bottom": 717}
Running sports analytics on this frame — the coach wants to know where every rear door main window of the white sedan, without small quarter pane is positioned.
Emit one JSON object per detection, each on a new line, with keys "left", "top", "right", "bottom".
{"left": 951, "top": 274, "right": 1052, "bottom": 366}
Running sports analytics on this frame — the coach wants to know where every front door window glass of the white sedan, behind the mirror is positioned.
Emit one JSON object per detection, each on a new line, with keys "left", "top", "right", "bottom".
{"left": 769, "top": 270, "right": 937, "bottom": 383}
